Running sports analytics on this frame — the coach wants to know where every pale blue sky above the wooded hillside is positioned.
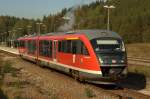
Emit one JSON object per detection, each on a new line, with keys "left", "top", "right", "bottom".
{"left": 0, "top": 0, "right": 96, "bottom": 19}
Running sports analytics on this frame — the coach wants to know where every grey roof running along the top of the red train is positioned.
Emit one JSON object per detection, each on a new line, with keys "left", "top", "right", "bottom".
{"left": 17, "top": 29, "right": 122, "bottom": 40}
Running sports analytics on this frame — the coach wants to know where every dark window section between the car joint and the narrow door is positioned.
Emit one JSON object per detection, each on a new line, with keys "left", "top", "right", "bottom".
{"left": 39, "top": 40, "right": 52, "bottom": 57}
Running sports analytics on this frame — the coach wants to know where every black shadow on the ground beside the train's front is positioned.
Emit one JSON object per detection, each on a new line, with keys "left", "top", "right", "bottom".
{"left": 96, "top": 73, "right": 146, "bottom": 90}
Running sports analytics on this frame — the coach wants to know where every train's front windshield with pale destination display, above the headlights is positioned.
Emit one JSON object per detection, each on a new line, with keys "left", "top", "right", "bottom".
{"left": 91, "top": 38, "right": 125, "bottom": 53}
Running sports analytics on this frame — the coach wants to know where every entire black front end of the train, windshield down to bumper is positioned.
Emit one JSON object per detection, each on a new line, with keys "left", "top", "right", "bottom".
{"left": 91, "top": 30, "right": 127, "bottom": 83}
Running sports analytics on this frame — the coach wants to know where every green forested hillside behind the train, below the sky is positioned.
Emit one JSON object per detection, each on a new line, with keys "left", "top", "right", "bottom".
{"left": 0, "top": 0, "right": 150, "bottom": 43}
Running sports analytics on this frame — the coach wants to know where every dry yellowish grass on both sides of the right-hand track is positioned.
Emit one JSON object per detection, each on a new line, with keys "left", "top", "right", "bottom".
{"left": 126, "top": 43, "right": 150, "bottom": 77}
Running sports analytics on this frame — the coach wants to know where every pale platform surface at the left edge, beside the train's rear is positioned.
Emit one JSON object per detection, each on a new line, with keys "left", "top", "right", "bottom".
{"left": 0, "top": 45, "right": 19, "bottom": 55}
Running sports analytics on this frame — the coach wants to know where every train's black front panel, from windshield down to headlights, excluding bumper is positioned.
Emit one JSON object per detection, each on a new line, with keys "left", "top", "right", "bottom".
{"left": 91, "top": 38, "right": 126, "bottom": 65}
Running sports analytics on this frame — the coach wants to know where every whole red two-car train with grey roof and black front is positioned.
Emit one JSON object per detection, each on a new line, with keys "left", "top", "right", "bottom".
{"left": 18, "top": 30, "right": 127, "bottom": 83}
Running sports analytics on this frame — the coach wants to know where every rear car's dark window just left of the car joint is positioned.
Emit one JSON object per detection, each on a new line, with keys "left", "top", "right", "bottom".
{"left": 27, "top": 40, "right": 36, "bottom": 54}
